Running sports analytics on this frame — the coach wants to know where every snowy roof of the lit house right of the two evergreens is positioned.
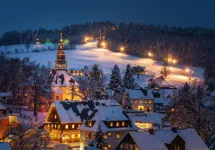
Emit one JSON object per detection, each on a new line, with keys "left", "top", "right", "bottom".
{"left": 126, "top": 89, "right": 153, "bottom": 99}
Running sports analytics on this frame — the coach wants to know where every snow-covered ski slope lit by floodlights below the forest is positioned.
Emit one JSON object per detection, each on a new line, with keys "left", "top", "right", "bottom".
{"left": 4, "top": 42, "right": 204, "bottom": 86}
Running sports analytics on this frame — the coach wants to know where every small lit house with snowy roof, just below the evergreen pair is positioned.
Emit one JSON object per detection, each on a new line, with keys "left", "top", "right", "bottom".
{"left": 122, "top": 88, "right": 154, "bottom": 111}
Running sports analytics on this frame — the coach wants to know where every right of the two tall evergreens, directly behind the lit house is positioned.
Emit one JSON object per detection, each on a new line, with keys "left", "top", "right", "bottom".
{"left": 122, "top": 64, "right": 135, "bottom": 89}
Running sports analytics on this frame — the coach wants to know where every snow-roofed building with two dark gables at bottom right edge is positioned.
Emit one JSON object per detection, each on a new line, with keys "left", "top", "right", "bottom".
{"left": 116, "top": 129, "right": 208, "bottom": 150}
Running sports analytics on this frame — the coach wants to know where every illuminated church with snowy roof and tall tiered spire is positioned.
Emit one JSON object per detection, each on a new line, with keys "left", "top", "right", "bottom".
{"left": 51, "top": 33, "right": 82, "bottom": 101}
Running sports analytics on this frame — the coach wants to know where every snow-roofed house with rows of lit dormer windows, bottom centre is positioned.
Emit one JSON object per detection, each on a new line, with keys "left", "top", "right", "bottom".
{"left": 79, "top": 101, "right": 137, "bottom": 150}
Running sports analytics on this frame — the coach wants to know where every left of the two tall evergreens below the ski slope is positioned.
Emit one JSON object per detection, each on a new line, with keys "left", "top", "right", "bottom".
{"left": 109, "top": 65, "right": 122, "bottom": 91}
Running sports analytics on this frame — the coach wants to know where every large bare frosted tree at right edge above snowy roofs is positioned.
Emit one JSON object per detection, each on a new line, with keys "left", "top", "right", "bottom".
{"left": 167, "top": 81, "right": 215, "bottom": 142}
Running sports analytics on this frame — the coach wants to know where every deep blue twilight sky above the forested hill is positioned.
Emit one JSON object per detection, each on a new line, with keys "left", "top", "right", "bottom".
{"left": 0, "top": 0, "right": 215, "bottom": 35}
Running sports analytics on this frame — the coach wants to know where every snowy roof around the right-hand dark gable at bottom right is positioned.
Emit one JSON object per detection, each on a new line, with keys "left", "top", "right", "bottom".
{"left": 154, "top": 129, "right": 208, "bottom": 150}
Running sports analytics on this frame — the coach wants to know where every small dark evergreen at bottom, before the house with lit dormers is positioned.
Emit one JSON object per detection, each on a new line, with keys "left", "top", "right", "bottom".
{"left": 95, "top": 124, "right": 106, "bottom": 149}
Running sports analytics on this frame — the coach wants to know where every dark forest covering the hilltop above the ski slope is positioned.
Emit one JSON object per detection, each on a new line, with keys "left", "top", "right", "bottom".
{"left": 0, "top": 21, "right": 215, "bottom": 85}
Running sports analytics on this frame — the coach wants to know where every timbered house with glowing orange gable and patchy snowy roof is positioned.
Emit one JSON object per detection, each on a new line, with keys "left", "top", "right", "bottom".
{"left": 44, "top": 100, "right": 119, "bottom": 146}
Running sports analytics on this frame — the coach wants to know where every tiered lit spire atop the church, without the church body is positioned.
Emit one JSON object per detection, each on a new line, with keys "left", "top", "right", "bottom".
{"left": 55, "top": 33, "right": 67, "bottom": 70}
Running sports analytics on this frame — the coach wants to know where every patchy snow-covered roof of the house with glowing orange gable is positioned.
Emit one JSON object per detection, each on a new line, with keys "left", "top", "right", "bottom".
{"left": 47, "top": 100, "right": 120, "bottom": 123}
